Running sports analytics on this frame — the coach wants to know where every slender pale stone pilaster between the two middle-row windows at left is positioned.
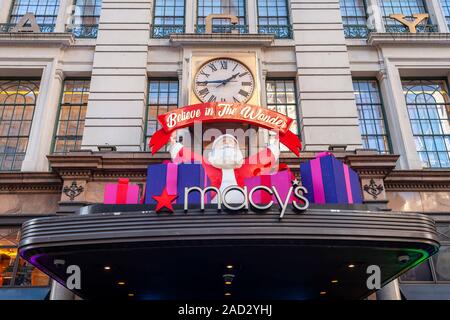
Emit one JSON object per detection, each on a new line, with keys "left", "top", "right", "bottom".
{"left": 22, "top": 63, "right": 64, "bottom": 171}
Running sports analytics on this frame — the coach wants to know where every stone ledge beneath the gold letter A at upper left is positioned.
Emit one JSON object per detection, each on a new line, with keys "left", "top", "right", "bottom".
{"left": 0, "top": 32, "right": 75, "bottom": 47}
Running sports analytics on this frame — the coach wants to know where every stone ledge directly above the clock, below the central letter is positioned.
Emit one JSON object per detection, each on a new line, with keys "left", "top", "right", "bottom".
{"left": 170, "top": 33, "right": 275, "bottom": 47}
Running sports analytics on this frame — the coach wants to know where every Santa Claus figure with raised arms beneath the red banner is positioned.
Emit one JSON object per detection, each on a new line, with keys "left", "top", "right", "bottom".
{"left": 169, "top": 134, "right": 279, "bottom": 203}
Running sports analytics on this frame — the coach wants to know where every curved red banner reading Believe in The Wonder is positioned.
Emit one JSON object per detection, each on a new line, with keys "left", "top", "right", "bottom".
{"left": 150, "top": 102, "right": 301, "bottom": 156}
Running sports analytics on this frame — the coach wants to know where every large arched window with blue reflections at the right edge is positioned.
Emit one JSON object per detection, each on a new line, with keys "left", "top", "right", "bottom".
{"left": 402, "top": 80, "right": 450, "bottom": 168}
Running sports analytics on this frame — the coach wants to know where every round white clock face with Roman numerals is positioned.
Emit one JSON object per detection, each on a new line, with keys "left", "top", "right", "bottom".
{"left": 194, "top": 58, "right": 255, "bottom": 102}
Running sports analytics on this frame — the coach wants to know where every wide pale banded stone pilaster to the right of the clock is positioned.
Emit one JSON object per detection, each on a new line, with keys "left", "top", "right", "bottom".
{"left": 290, "top": 0, "right": 362, "bottom": 151}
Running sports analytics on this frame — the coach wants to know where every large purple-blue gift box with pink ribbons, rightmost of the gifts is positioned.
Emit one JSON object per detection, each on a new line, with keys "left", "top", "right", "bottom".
{"left": 300, "top": 152, "right": 362, "bottom": 204}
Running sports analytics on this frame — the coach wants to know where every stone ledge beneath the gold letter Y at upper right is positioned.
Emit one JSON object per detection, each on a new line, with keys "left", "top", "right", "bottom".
{"left": 367, "top": 32, "right": 450, "bottom": 45}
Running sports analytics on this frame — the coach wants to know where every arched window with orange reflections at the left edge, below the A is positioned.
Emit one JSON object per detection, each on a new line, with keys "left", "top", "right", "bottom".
{"left": 0, "top": 80, "right": 39, "bottom": 171}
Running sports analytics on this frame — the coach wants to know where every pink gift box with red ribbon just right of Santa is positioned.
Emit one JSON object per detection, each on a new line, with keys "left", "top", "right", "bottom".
{"left": 244, "top": 166, "right": 294, "bottom": 204}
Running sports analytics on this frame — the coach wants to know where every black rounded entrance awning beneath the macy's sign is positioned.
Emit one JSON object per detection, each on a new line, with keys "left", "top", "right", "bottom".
{"left": 19, "top": 205, "right": 439, "bottom": 300}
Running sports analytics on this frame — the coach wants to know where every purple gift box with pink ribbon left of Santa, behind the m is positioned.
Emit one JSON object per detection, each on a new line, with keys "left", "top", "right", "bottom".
{"left": 145, "top": 163, "right": 209, "bottom": 204}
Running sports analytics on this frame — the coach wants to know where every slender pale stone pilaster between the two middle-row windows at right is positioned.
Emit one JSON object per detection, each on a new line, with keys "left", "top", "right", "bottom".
{"left": 377, "top": 63, "right": 422, "bottom": 170}
